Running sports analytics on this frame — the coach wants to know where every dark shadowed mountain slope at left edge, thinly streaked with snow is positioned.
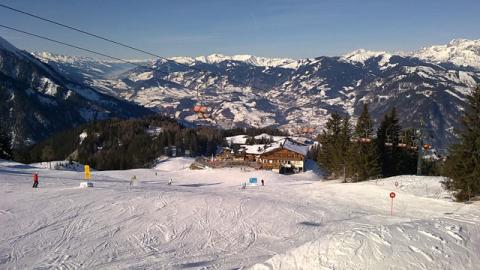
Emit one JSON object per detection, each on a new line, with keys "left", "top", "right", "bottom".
{"left": 0, "top": 35, "right": 152, "bottom": 147}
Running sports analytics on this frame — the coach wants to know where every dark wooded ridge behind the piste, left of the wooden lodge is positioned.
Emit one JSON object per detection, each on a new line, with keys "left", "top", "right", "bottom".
{"left": 22, "top": 117, "right": 223, "bottom": 170}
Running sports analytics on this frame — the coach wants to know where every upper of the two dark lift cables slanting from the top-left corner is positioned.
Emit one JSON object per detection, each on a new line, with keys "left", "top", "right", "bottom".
{"left": 0, "top": 3, "right": 266, "bottom": 94}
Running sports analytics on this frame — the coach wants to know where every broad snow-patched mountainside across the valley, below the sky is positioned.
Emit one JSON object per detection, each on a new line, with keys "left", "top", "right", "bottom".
{"left": 23, "top": 40, "right": 480, "bottom": 148}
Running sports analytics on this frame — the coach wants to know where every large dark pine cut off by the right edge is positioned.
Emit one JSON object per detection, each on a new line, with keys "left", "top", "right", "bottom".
{"left": 444, "top": 86, "right": 480, "bottom": 201}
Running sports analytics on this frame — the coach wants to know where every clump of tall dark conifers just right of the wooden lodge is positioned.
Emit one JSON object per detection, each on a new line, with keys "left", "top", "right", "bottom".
{"left": 317, "top": 104, "right": 426, "bottom": 181}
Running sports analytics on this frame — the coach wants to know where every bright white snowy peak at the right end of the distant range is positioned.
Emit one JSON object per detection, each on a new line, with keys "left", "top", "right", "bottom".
{"left": 412, "top": 39, "right": 480, "bottom": 70}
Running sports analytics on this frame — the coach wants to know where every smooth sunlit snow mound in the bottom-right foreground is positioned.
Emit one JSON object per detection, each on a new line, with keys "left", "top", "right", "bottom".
{"left": 251, "top": 218, "right": 480, "bottom": 270}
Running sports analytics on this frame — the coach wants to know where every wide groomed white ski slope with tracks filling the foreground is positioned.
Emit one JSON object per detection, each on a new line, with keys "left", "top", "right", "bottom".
{"left": 0, "top": 159, "right": 480, "bottom": 269}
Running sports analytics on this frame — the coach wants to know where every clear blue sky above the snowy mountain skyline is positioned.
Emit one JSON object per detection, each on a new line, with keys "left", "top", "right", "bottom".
{"left": 0, "top": 0, "right": 480, "bottom": 58}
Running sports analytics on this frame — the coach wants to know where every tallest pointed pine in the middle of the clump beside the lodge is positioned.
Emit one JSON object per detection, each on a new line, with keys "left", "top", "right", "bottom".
{"left": 351, "top": 104, "right": 381, "bottom": 181}
